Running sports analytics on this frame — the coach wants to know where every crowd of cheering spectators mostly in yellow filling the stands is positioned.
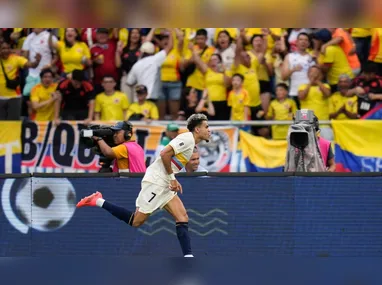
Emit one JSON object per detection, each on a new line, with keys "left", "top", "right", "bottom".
{"left": 0, "top": 28, "right": 382, "bottom": 139}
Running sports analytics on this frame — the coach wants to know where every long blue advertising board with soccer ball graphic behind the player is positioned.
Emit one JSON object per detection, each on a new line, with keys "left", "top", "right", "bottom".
{"left": 0, "top": 173, "right": 382, "bottom": 257}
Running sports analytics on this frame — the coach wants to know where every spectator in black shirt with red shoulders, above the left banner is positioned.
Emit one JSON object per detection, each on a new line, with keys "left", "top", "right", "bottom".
{"left": 54, "top": 69, "right": 95, "bottom": 124}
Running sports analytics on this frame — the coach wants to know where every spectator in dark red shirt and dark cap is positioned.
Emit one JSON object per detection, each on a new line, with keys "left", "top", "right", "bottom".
{"left": 90, "top": 28, "right": 119, "bottom": 94}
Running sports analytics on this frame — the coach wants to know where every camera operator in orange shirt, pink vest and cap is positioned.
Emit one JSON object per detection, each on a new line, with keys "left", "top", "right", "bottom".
{"left": 92, "top": 121, "right": 146, "bottom": 172}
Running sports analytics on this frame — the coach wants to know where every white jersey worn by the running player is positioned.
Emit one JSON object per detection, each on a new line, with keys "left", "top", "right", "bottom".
{"left": 142, "top": 132, "right": 195, "bottom": 187}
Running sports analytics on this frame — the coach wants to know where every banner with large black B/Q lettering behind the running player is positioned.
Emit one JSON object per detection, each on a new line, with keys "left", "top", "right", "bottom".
{"left": 21, "top": 121, "right": 238, "bottom": 173}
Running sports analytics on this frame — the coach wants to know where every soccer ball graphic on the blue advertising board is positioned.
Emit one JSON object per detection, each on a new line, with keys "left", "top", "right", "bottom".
{"left": 1, "top": 178, "right": 76, "bottom": 234}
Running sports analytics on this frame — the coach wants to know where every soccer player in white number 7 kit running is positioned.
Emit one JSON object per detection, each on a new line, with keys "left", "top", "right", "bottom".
{"left": 77, "top": 114, "right": 211, "bottom": 257}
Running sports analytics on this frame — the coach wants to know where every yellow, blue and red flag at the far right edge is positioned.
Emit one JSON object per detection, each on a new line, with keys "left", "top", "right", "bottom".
{"left": 332, "top": 120, "right": 382, "bottom": 172}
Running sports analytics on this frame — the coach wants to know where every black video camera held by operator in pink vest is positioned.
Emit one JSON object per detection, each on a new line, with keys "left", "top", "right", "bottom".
{"left": 80, "top": 125, "right": 116, "bottom": 173}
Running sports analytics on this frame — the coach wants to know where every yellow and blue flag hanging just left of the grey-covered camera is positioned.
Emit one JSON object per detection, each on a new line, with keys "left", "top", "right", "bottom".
{"left": 240, "top": 131, "right": 287, "bottom": 172}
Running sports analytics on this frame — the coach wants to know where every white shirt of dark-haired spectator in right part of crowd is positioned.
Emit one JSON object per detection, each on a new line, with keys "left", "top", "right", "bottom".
{"left": 288, "top": 52, "right": 315, "bottom": 96}
